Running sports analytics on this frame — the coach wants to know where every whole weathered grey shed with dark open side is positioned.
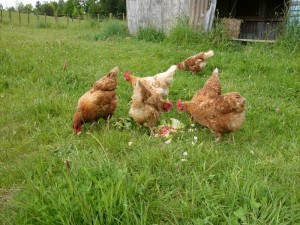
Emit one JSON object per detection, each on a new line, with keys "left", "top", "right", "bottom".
{"left": 126, "top": 0, "right": 300, "bottom": 39}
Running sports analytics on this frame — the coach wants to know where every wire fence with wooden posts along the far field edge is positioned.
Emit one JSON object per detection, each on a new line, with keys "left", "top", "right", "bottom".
{"left": 0, "top": 10, "right": 126, "bottom": 26}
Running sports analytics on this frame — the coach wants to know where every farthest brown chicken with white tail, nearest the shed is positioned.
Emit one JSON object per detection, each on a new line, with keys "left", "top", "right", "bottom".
{"left": 177, "top": 50, "right": 214, "bottom": 73}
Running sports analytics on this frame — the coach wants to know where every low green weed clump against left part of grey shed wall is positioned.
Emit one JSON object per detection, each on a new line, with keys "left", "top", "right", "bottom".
{"left": 136, "top": 27, "right": 166, "bottom": 42}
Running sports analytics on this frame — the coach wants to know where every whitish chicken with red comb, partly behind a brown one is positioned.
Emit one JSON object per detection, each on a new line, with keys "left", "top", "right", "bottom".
{"left": 124, "top": 65, "right": 177, "bottom": 98}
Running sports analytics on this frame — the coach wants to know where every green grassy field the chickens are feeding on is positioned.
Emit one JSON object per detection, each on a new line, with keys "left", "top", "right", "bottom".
{"left": 0, "top": 19, "right": 300, "bottom": 224}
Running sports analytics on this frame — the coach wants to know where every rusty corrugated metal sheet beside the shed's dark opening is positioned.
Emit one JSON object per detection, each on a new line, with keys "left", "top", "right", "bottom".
{"left": 190, "top": 0, "right": 217, "bottom": 31}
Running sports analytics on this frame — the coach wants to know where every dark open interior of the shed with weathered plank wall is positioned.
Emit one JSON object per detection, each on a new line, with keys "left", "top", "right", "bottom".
{"left": 216, "top": 0, "right": 300, "bottom": 39}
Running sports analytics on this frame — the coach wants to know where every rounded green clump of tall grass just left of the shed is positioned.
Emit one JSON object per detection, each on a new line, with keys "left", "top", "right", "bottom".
{"left": 94, "top": 20, "right": 128, "bottom": 40}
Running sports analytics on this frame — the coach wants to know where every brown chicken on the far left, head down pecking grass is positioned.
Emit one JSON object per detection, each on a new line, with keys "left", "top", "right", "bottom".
{"left": 73, "top": 67, "right": 119, "bottom": 134}
